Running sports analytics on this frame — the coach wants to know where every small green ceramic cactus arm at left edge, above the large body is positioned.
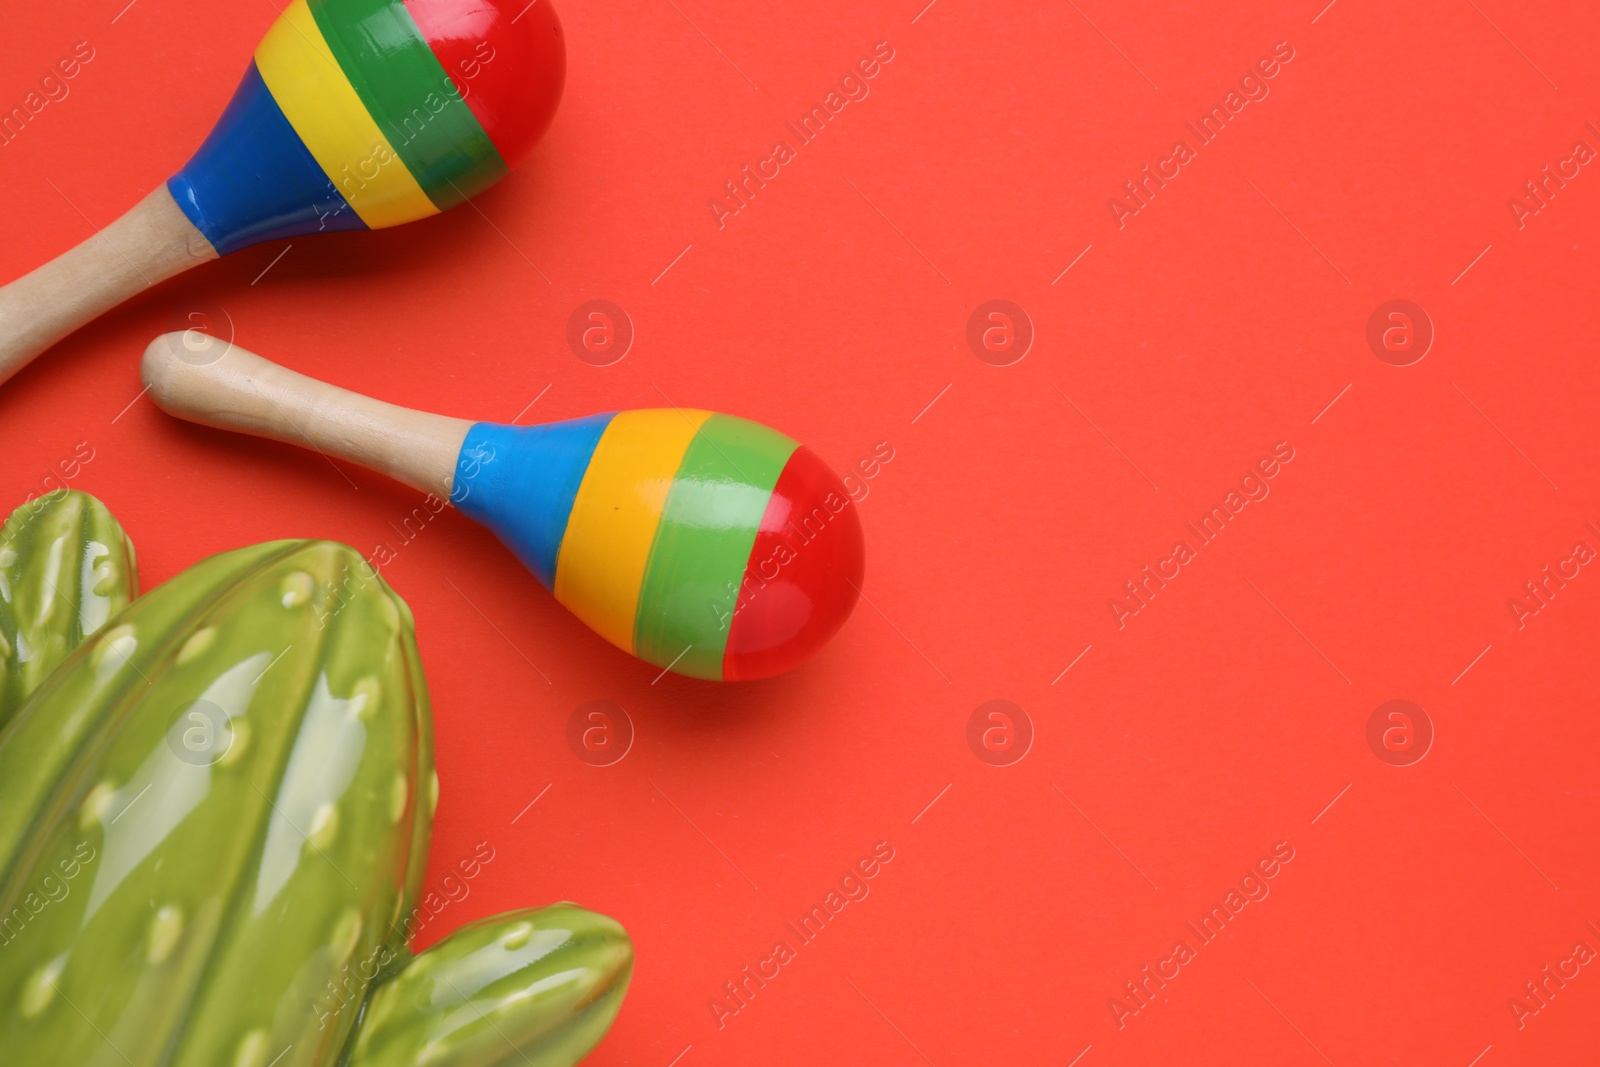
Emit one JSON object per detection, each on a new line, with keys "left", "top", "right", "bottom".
{"left": 0, "top": 490, "right": 139, "bottom": 729}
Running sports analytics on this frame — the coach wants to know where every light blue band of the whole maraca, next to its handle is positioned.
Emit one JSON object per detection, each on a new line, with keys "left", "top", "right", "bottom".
{"left": 450, "top": 411, "right": 616, "bottom": 590}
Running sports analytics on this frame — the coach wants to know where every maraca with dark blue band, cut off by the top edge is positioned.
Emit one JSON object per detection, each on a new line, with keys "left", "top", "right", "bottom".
{"left": 0, "top": 0, "right": 566, "bottom": 390}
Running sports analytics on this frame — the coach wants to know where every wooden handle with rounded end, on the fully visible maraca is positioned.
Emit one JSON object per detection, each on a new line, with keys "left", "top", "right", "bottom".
{"left": 141, "top": 330, "right": 474, "bottom": 499}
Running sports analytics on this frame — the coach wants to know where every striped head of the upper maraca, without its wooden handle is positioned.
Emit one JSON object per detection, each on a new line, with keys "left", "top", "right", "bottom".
{"left": 168, "top": 0, "right": 565, "bottom": 254}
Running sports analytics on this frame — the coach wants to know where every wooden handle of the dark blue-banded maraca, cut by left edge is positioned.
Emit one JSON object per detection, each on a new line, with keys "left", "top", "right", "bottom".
{"left": 0, "top": 182, "right": 218, "bottom": 382}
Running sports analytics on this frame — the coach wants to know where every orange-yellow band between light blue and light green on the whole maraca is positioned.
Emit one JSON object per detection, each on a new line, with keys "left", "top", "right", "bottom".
{"left": 555, "top": 408, "right": 710, "bottom": 653}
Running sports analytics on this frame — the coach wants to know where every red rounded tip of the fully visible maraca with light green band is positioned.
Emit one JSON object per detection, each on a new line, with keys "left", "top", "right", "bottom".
{"left": 722, "top": 445, "right": 866, "bottom": 681}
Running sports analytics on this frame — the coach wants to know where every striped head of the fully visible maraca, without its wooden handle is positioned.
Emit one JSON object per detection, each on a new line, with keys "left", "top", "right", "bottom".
{"left": 451, "top": 408, "right": 864, "bottom": 680}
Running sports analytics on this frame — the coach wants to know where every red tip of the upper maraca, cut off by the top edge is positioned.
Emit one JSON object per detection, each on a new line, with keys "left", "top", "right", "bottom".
{"left": 405, "top": 0, "right": 566, "bottom": 166}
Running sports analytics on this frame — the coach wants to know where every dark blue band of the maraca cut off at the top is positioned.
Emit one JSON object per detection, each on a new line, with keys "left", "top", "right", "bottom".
{"left": 166, "top": 62, "right": 366, "bottom": 256}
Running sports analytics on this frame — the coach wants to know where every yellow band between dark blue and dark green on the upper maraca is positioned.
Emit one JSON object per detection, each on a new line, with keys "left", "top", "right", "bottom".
{"left": 256, "top": 0, "right": 438, "bottom": 230}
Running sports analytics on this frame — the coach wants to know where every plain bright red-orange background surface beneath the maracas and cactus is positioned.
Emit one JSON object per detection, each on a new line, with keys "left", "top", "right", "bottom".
{"left": 0, "top": 0, "right": 1600, "bottom": 1067}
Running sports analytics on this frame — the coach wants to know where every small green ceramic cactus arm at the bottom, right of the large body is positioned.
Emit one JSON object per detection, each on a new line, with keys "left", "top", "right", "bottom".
{"left": 339, "top": 904, "right": 634, "bottom": 1067}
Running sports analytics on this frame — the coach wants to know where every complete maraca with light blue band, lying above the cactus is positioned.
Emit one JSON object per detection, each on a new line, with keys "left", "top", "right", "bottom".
{"left": 144, "top": 333, "right": 862, "bottom": 681}
